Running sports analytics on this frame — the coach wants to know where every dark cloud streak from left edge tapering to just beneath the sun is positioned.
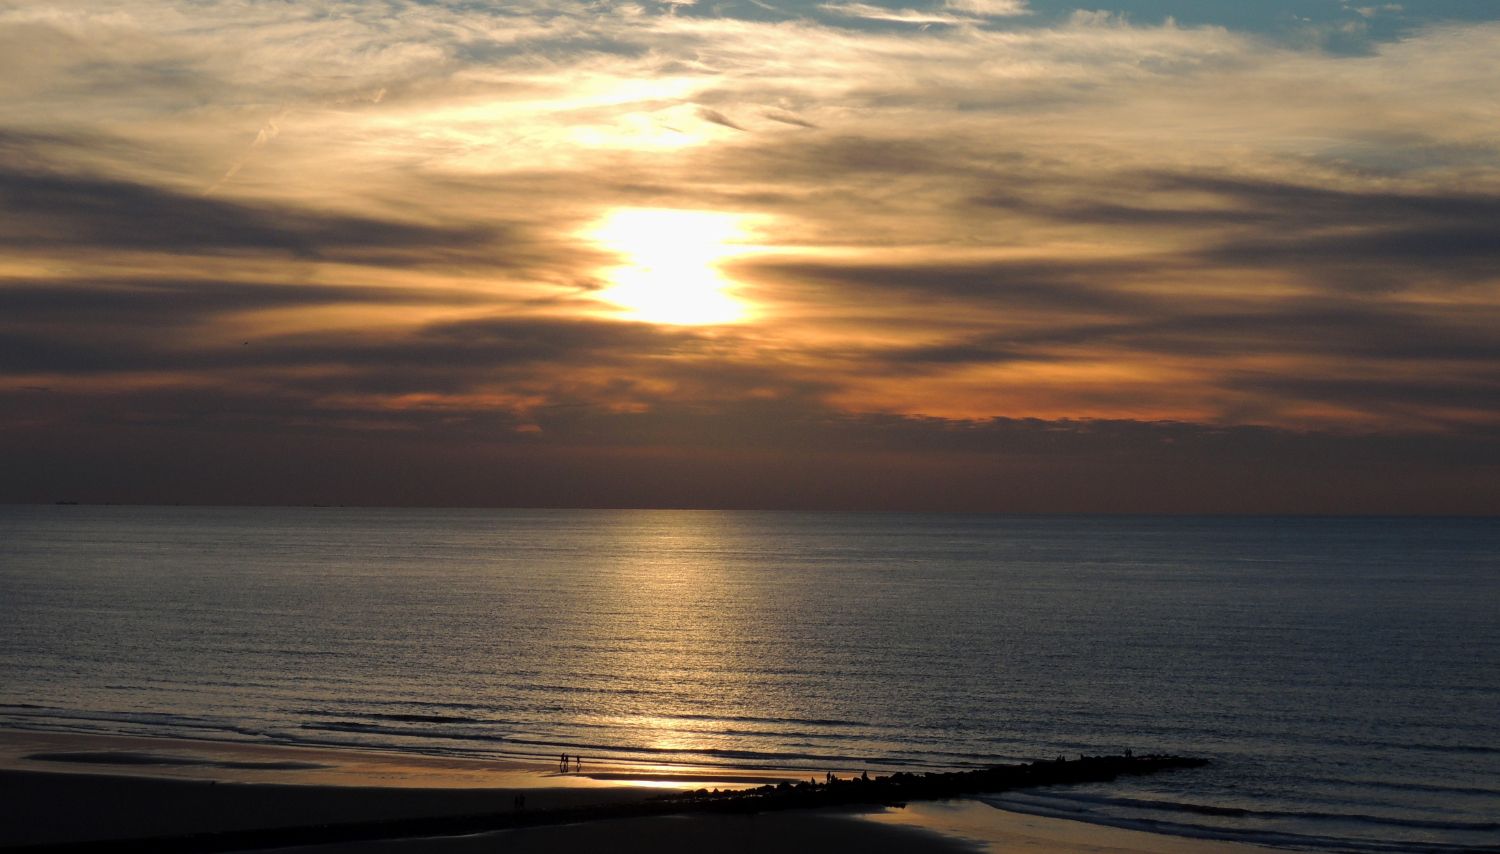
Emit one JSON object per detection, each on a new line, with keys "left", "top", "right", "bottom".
{"left": 0, "top": 303, "right": 714, "bottom": 376}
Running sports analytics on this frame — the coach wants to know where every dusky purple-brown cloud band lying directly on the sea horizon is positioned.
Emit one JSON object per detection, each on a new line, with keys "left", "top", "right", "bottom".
{"left": 0, "top": 387, "right": 1500, "bottom": 513}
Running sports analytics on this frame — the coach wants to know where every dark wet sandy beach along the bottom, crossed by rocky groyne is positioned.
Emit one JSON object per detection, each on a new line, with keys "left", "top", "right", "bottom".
{"left": 0, "top": 731, "right": 1266, "bottom": 854}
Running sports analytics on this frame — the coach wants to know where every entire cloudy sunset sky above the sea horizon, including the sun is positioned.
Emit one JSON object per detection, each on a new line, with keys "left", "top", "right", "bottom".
{"left": 0, "top": 0, "right": 1500, "bottom": 513}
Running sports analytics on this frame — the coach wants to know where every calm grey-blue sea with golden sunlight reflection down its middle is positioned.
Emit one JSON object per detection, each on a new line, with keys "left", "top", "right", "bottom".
{"left": 0, "top": 507, "right": 1500, "bottom": 851}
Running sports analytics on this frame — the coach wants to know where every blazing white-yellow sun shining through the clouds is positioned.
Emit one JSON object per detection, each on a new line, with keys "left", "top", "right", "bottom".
{"left": 585, "top": 209, "right": 750, "bottom": 326}
